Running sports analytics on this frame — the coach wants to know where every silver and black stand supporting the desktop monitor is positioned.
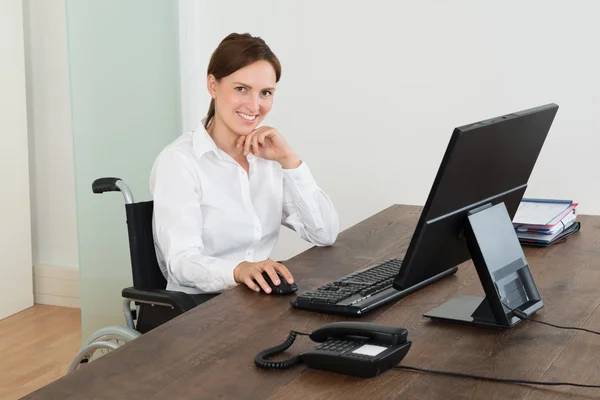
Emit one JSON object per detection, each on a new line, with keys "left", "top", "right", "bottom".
{"left": 424, "top": 203, "right": 544, "bottom": 329}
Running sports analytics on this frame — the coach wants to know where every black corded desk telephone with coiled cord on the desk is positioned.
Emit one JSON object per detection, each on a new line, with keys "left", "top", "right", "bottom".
{"left": 254, "top": 322, "right": 412, "bottom": 378}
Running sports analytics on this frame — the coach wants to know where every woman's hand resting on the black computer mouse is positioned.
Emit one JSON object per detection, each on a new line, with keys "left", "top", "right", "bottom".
{"left": 233, "top": 258, "right": 294, "bottom": 293}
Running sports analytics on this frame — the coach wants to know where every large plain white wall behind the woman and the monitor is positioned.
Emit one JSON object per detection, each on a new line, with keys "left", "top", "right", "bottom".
{"left": 183, "top": 0, "right": 600, "bottom": 258}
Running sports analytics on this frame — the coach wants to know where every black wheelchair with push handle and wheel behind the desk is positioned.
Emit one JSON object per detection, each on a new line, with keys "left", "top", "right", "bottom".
{"left": 67, "top": 178, "right": 217, "bottom": 374}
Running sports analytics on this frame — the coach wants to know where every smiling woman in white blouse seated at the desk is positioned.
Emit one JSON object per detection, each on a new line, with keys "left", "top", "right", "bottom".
{"left": 150, "top": 33, "right": 339, "bottom": 300}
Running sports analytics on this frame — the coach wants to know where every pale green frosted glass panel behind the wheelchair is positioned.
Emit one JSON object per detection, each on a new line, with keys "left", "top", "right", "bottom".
{"left": 67, "top": 0, "right": 181, "bottom": 337}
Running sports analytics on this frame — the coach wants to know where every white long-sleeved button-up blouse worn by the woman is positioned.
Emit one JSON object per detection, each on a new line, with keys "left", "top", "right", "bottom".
{"left": 150, "top": 122, "right": 339, "bottom": 294}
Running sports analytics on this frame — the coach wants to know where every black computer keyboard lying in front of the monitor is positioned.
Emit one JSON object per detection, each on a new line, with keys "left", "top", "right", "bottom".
{"left": 291, "top": 258, "right": 405, "bottom": 315}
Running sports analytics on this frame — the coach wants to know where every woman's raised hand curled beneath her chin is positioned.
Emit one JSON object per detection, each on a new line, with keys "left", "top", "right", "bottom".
{"left": 237, "top": 126, "right": 302, "bottom": 169}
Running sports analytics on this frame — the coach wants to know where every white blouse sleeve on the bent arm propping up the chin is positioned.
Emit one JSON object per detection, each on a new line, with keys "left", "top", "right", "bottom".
{"left": 282, "top": 162, "right": 339, "bottom": 246}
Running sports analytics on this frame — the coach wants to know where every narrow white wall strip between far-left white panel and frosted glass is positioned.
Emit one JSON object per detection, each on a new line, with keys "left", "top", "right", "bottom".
{"left": 23, "top": 0, "right": 78, "bottom": 269}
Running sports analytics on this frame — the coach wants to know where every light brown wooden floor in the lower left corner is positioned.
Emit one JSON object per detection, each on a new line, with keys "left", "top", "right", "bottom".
{"left": 0, "top": 304, "right": 81, "bottom": 399}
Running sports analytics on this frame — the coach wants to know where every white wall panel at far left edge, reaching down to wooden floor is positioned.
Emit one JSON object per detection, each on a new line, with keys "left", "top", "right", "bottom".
{"left": 0, "top": 0, "right": 33, "bottom": 319}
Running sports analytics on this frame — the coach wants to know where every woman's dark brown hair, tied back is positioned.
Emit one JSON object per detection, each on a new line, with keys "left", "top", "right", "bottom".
{"left": 205, "top": 33, "right": 281, "bottom": 127}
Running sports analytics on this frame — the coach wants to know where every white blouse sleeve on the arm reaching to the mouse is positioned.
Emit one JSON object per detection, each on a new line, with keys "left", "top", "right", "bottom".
{"left": 150, "top": 151, "right": 238, "bottom": 292}
